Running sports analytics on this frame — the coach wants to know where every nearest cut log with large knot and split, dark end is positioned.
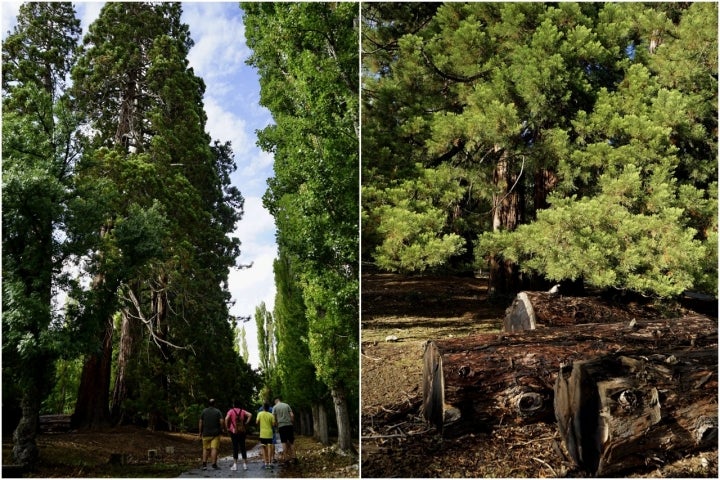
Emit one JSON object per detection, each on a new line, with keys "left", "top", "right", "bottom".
{"left": 554, "top": 347, "right": 718, "bottom": 475}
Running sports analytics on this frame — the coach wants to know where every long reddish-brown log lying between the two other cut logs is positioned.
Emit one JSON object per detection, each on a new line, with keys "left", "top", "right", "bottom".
{"left": 422, "top": 315, "right": 717, "bottom": 435}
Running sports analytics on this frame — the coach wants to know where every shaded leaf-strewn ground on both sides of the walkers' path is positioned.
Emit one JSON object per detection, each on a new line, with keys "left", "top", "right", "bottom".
{"left": 2, "top": 426, "right": 359, "bottom": 478}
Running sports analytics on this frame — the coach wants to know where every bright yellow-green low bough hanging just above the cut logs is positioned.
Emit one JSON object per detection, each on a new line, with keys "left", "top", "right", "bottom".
{"left": 479, "top": 165, "right": 706, "bottom": 297}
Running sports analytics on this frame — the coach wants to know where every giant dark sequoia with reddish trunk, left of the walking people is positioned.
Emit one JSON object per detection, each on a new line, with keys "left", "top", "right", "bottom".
{"left": 73, "top": 3, "right": 248, "bottom": 427}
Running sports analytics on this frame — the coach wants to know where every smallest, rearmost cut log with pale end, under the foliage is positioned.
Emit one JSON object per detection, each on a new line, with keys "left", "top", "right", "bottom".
{"left": 503, "top": 292, "right": 657, "bottom": 332}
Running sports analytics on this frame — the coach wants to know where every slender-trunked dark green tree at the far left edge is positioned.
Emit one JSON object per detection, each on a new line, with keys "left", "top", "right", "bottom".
{"left": 2, "top": 3, "right": 80, "bottom": 468}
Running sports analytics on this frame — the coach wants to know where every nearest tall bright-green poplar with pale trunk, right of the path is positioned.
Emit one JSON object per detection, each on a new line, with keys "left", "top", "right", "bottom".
{"left": 242, "top": 3, "right": 359, "bottom": 451}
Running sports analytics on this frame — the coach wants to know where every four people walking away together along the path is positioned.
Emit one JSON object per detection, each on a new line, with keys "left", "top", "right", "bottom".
{"left": 198, "top": 397, "right": 298, "bottom": 471}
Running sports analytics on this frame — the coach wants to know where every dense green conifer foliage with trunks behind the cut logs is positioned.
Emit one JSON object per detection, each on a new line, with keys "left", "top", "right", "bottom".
{"left": 362, "top": 2, "right": 718, "bottom": 297}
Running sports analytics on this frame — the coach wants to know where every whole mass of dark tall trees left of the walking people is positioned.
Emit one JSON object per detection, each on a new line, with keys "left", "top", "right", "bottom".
{"left": 2, "top": 2, "right": 260, "bottom": 467}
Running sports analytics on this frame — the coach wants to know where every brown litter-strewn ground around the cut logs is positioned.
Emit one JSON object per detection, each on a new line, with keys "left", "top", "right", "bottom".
{"left": 361, "top": 273, "right": 718, "bottom": 478}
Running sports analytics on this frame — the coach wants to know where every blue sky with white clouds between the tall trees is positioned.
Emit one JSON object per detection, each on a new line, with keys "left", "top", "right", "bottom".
{"left": 0, "top": 1, "right": 277, "bottom": 367}
